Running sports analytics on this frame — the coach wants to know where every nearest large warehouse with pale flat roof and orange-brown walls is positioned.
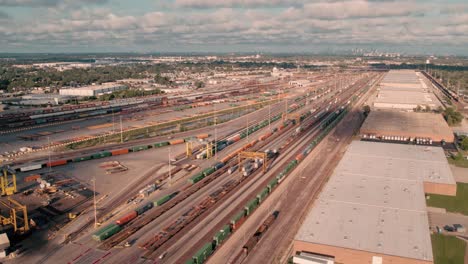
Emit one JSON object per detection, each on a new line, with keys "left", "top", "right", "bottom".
{"left": 293, "top": 141, "right": 456, "bottom": 264}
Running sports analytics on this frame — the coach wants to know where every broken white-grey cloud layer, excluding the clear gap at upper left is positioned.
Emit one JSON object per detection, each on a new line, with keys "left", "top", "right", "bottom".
{"left": 0, "top": 0, "right": 468, "bottom": 54}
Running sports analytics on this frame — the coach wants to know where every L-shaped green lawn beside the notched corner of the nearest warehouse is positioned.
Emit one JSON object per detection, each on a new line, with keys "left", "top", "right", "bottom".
{"left": 426, "top": 182, "right": 468, "bottom": 215}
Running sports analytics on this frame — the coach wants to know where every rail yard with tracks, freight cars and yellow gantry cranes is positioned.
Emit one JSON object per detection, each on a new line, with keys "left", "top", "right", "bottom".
{"left": 0, "top": 66, "right": 388, "bottom": 263}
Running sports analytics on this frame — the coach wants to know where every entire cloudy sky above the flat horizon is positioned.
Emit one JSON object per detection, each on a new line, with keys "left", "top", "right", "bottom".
{"left": 0, "top": 0, "right": 468, "bottom": 55}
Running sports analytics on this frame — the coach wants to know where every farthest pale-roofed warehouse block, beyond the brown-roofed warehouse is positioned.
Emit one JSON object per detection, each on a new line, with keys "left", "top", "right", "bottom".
{"left": 374, "top": 70, "right": 440, "bottom": 110}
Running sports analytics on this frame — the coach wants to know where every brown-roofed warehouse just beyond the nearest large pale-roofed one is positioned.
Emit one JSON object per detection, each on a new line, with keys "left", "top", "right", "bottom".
{"left": 360, "top": 109, "right": 454, "bottom": 143}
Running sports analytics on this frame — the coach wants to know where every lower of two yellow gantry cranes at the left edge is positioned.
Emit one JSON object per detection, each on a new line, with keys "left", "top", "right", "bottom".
{"left": 0, "top": 197, "right": 29, "bottom": 233}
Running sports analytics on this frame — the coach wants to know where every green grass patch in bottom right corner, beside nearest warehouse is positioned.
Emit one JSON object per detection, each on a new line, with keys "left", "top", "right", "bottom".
{"left": 431, "top": 234, "right": 466, "bottom": 264}
